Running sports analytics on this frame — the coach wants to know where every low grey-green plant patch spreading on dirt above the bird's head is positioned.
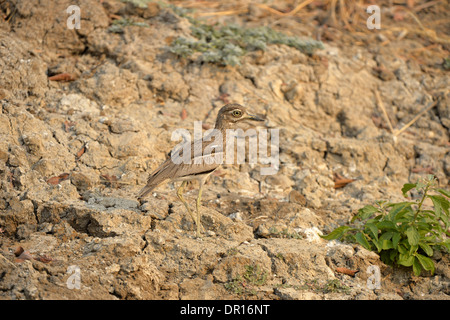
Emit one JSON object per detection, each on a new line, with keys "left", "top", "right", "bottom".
{"left": 169, "top": 7, "right": 323, "bottom": 66}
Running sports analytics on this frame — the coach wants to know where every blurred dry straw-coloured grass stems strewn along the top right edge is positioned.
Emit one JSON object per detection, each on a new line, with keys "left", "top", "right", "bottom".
{"left": 172, "top": 0, "right": 450, "bottom": 44}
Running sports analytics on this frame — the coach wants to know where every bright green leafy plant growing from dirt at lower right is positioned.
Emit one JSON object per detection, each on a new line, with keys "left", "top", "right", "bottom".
{"left": 322, "top": 175, "right": 450, "bottom": 275}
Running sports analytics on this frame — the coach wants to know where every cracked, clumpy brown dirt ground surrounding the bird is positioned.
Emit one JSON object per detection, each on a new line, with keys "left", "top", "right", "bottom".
{"left": 0, "top": 0, "right": 450, "bottom": 299}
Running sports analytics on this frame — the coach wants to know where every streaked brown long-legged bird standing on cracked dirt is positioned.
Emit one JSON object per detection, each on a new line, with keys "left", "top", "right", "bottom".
{"left": 137, "top": 103, "right": 265, "bottom": 238}
